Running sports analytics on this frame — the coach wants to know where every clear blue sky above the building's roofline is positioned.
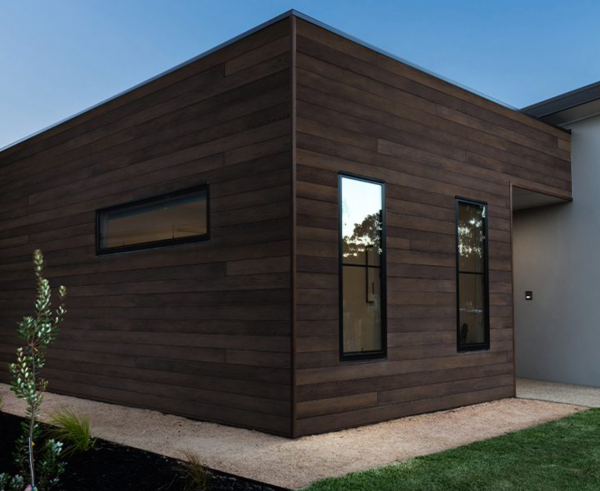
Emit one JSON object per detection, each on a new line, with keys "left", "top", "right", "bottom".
{"left": 0, "top": 0, "right": 600, "bottom": 147}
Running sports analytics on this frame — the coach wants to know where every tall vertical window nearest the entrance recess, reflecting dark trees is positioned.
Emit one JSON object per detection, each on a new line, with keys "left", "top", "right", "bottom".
{"left": 456, "top": 198, "right": 490, "bottom": 351}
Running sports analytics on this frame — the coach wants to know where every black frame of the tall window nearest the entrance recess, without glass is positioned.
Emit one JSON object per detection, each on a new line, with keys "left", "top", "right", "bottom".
{"left": 455, "top": 196, "right": 491, "bottom": 353}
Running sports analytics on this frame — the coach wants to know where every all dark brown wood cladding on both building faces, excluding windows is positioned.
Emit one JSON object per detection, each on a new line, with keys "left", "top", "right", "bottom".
{"left": 0, "top": 16, "right": 571, "bottom": 436}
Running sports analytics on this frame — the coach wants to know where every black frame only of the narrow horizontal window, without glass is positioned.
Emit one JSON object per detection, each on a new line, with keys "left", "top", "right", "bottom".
{"left": 96, "top": 182, "right": 210, "bottom": 256}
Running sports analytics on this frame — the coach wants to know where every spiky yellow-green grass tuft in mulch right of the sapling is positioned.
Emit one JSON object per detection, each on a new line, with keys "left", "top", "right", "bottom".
{"left": 48, "top": 408, "right": 96, "bottom": 456}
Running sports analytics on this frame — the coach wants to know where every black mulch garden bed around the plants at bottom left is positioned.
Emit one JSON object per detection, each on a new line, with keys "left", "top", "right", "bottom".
{"left": 0, "top": 413, "right": 285, "bottom": 491}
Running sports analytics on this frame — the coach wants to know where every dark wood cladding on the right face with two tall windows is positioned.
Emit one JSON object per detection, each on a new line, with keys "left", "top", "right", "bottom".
{"left": 295, "top": 19, "right": 571, "bottom": 436}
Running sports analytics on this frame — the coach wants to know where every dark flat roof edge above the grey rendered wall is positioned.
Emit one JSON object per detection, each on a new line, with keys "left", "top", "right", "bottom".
{"left": 521, "top": 82, "right": 600, "bottom": 126}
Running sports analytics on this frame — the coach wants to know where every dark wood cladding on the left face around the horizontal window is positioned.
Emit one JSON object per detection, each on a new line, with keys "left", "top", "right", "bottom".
{"left": 0, "top": 19, "right": 292, "bottom": 435}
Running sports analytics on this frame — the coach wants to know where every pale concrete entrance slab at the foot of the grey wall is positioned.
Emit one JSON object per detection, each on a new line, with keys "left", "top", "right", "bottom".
{"left": 517, "top": 379, "right": 600, "bottom": 407}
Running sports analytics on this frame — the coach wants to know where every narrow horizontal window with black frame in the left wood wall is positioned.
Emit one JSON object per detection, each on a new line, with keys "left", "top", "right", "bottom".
{"left": 96, "top": 184, "right": 209, "bottom": 254}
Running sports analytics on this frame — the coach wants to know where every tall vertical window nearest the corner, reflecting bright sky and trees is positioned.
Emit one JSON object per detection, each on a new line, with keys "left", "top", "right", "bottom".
{"left": 339, "top": 175, "right": 386, "bottom": 360}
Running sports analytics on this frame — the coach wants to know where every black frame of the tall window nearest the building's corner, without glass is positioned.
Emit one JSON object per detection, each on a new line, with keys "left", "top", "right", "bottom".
{"left": 338, "top": 172, "right": 388, "bottom": 361}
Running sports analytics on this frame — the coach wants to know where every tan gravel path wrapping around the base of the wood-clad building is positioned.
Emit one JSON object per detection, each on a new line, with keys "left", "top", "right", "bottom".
{"left": 0, "top": 384, "right": 582, "bottom": 489}
